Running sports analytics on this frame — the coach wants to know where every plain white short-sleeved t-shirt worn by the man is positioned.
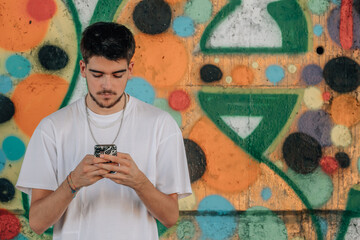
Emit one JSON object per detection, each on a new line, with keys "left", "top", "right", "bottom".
{"left": 16, "top": 97, "right": 191, "bottom": 240}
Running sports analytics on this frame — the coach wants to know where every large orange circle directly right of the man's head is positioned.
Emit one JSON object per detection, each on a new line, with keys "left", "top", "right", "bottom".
{"left": 134, "top": 33, "right": 189, "bottom": 88}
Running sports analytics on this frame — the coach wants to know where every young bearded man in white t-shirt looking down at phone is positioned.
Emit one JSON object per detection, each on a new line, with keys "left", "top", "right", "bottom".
{"left": 17, "top": 23, "right": 191, "bottom": 240}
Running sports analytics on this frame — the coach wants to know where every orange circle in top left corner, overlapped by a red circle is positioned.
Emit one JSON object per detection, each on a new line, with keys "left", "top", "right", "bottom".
{"left": 0, "top": 0, "right": 49, "bottom": 51}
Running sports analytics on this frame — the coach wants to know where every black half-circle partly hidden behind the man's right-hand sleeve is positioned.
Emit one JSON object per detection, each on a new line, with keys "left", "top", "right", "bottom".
{"left": 184, "top": 139, "right": 206, "bottom": 182}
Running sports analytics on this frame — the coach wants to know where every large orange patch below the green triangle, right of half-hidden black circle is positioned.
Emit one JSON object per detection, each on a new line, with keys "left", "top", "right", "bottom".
{"left": 189, "top": 117, "right": 260, "bottom": 193}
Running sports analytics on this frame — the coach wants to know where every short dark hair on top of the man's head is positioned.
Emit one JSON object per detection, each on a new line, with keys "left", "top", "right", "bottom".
{"left": 80, "top": 22, "right": 135, "bottom": 63}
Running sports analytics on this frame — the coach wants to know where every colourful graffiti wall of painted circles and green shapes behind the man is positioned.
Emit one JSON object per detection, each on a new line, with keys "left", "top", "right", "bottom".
{"left": 0, "top": 0, "right": 360, "bottom": 240}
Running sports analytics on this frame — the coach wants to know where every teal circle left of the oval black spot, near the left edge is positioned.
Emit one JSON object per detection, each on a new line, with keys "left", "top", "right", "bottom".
{"left": 5, "top": 54, "right": 31, "bottom": 78}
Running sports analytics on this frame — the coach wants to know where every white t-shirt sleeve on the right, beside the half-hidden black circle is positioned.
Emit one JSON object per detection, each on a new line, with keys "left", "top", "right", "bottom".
{"left": 156, "top": 114, "right": 192, "bottom": 199}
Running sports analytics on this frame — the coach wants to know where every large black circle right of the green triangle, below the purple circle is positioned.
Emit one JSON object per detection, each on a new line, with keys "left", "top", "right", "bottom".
{"left": 282, "top": 132, "right": 322, "bottom": 174}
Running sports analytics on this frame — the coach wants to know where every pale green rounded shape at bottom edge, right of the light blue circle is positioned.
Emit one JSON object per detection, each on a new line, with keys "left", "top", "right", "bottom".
{"left": 239, "top": 206, "right": 288, "bottom": 240}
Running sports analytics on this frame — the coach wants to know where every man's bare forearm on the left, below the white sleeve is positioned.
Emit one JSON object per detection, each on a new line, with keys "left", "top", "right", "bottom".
{"left": 29, "top": 180, "right": 74, "bottom": 234}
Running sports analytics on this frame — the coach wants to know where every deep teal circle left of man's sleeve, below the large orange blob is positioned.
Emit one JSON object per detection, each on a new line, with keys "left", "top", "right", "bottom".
{"left": 2, "top": 136, "right": 25, "bottom": 161}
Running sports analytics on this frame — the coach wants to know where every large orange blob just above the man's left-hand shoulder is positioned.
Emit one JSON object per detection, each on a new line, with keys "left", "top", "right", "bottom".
{"left": 12, "top": 74, "right": 69, "bottom": 137}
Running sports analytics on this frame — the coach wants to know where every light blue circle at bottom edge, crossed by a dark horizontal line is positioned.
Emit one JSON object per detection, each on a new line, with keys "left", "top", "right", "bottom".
{"left": 195, "top": 195, "right": 236, "bottom": 240}
